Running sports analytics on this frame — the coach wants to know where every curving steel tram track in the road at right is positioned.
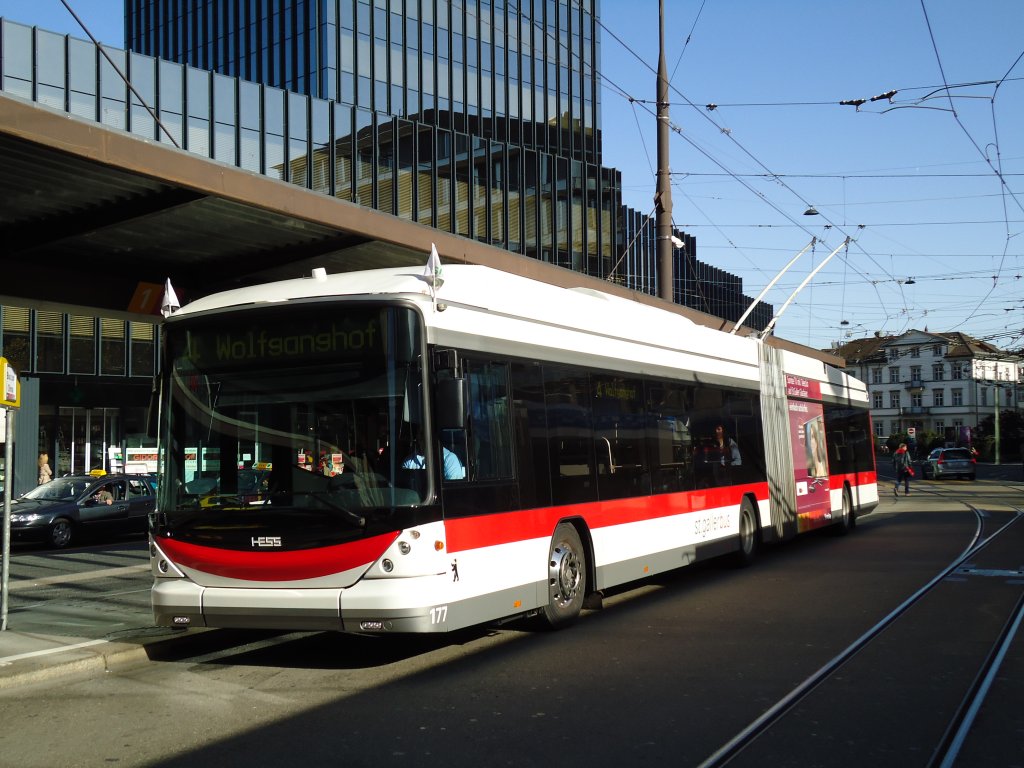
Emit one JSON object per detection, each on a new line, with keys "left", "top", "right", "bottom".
{"left": 699, "top": 501, "right": 1024, "bottom": 768}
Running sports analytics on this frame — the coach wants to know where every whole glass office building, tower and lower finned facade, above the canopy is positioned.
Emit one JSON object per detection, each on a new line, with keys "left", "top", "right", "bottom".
{"left": 0, "top": 9, "right": 771, "bottom": 328}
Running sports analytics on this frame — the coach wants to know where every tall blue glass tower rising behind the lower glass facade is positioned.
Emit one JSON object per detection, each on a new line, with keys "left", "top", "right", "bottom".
{"left": 125, "top": 0, "right": 601, "bottom": 163}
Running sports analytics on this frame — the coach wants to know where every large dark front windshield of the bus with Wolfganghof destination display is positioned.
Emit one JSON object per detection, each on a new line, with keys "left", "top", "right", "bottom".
{"left": 160, "top": 302, "right": 426, "bottom": 528}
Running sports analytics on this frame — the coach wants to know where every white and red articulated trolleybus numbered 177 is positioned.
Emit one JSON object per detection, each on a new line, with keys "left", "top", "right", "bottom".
{"left": 152, "top": 265, "right": 879, "bottom": 634}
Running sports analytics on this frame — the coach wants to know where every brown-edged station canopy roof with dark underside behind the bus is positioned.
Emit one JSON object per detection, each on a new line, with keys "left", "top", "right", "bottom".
{"left": 0, "top": 92, "right": 842, "bottom": 365}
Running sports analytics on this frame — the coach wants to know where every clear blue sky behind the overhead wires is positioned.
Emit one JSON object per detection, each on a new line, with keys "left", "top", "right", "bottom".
{"left": 0, "top": 0, "right": 1024, "bottom": 348}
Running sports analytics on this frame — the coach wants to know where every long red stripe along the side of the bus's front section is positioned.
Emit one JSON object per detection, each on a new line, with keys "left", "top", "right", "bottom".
{"left": 444, "top": 483, "right": 768, "bottom": 553}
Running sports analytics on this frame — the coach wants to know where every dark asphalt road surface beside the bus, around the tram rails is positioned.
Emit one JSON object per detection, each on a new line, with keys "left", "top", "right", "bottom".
{"left": 0, "top": 475, "right": 1024, "bottom": 768}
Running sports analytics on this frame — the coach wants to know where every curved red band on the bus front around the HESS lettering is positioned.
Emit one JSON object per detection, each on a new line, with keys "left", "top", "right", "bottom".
{"left": 157, "top": 531, "right": 397, "bottom": 582}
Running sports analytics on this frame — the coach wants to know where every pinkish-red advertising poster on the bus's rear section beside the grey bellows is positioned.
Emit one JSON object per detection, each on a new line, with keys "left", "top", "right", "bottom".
{"left": 786, "top": 376, "right": 831, "bottom": 531}
